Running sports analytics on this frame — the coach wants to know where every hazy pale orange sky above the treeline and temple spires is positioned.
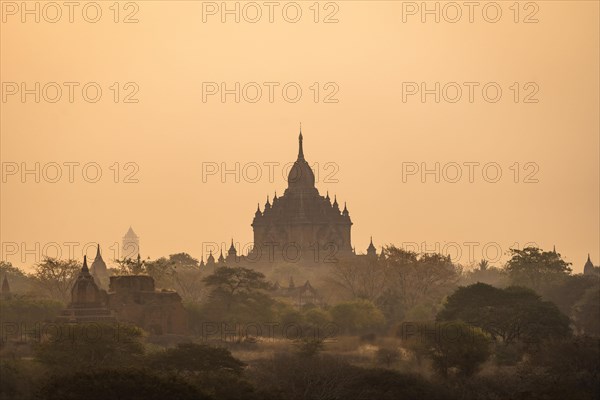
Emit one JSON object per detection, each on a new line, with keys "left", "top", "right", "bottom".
{"left": 0, "top": 1, "right": 600, "bottom": 272}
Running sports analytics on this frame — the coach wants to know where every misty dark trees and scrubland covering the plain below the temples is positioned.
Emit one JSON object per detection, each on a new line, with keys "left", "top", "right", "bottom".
{"left": 0, "top": 245, "right": 600, "bottom": 400}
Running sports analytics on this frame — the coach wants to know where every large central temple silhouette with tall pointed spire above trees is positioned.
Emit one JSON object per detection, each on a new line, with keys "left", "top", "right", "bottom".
{"left": 201, "top": 128, "right": 377, "bottom": 267}
